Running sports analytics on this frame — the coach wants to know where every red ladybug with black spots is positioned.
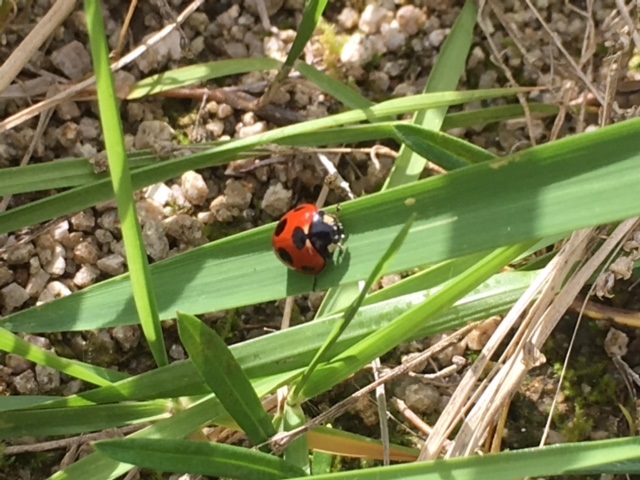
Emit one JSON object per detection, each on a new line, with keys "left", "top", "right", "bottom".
{"left": 272, "top": 203, "right": 344, "bottom": 275}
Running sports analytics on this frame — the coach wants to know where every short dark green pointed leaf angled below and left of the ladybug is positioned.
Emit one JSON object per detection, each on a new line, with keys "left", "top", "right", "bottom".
{"left": 178, "top": 312, "right": 276, "bottom": 445}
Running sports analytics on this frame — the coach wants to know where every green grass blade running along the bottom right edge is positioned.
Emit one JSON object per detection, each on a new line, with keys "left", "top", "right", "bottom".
{"left": 288, "top": 437, "right": 640, "bottom": 480}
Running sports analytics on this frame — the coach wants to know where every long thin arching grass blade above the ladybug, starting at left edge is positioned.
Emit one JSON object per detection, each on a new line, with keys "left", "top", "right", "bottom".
{"left": 0, "top": 88, "right": 522, "bottom": 234}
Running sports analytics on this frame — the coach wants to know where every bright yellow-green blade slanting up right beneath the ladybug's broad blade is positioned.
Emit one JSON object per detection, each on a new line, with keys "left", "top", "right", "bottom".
{"left": 298, "top": 242, "right": 533, "bottom": 402}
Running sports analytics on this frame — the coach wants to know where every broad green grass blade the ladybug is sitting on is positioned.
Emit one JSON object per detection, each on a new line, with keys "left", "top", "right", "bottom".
{"left": 1, "top": 119, "right": 640, "bottom": 332}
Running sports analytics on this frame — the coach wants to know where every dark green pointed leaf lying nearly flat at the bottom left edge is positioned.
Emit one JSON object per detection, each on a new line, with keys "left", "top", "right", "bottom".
{"left": 95, "top": 438, "right": 305, "bottom": 480}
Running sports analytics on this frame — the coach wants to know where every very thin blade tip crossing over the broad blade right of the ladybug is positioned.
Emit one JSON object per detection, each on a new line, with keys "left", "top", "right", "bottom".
{"left": 287, "top": 213, "right": 415, "bottom": 405}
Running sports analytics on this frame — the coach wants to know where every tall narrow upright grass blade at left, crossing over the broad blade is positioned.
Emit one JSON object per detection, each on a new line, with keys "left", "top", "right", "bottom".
{"left": 84, "top": 0, "right": 169, "bottom": 366}
